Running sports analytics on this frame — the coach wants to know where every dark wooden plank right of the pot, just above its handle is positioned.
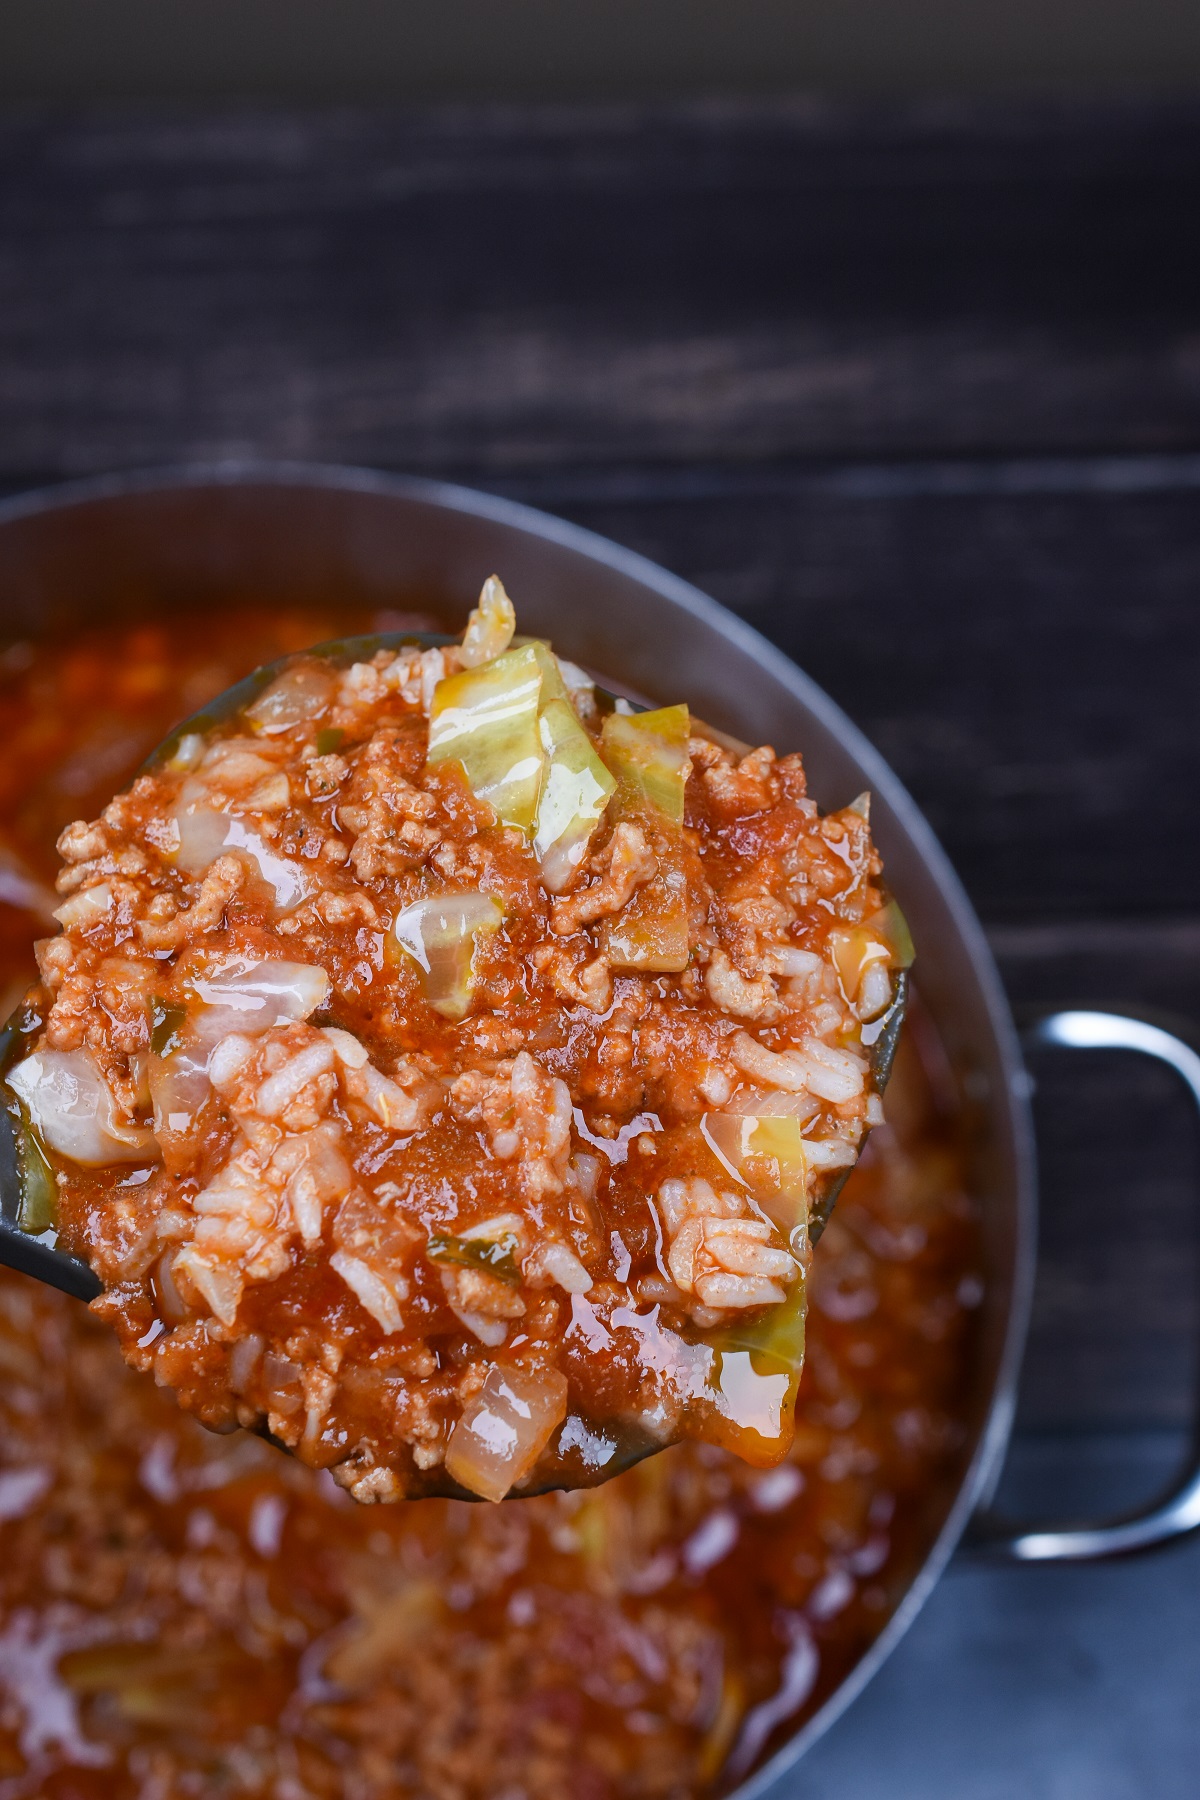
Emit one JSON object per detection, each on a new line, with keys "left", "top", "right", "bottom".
{"left": 536, "top": 471, "right": 1200, "bottom": 922}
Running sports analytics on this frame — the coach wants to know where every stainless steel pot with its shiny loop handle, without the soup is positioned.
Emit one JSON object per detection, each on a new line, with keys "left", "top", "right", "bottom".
{"left": 0, "top": 464, "right": 1200, "bottom": 1800}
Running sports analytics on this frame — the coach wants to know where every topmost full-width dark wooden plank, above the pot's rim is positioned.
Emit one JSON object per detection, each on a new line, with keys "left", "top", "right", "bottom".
{"left": 0, "top": 104, "right": 1200, "bottom": 479}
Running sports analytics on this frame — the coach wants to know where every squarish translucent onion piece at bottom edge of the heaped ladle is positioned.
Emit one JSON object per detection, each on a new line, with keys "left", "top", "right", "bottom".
{"left": 446, "top": 1364, "right": 567, "bottom": 1501}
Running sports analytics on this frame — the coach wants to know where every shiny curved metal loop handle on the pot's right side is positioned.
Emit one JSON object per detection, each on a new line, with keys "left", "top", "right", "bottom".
{"left": 964, "top": 1010, "right": 1200, "bottom": 1562}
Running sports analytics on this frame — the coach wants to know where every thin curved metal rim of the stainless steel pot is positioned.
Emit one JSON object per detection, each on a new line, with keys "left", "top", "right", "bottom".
{"left": 0, "top": 457, "right": 1036, "bottom": 1778}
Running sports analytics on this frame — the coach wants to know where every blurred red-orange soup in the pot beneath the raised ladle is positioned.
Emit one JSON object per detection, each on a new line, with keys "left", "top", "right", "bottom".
{"left": 0, "top": 608, "right": 981, "bottom": 1800}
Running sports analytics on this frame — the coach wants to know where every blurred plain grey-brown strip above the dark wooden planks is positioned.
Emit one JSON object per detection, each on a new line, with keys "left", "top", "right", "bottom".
{"left": 0, "top": 0, "right": 1200, "bottom": 101}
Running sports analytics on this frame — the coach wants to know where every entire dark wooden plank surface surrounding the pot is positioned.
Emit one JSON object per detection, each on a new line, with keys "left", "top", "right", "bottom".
{"left": 0, "top": 103, "right": 1200, "bottom": 1800}
